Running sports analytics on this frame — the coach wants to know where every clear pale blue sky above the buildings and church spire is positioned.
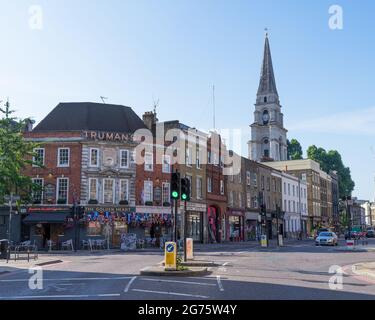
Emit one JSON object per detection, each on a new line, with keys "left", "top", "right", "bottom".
{"left": 0, "top": 0, "right": 375, "bottom": 199}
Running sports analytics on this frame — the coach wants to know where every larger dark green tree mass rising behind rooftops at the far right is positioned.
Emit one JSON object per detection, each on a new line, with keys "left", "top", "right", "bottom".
{"left": 307, "top": 145, "right": 355, "bottom": 197}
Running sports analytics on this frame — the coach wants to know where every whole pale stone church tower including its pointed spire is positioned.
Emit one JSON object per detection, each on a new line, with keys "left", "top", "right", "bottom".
{"left": 248, "top": 33, "right": 287, "bottom": 162}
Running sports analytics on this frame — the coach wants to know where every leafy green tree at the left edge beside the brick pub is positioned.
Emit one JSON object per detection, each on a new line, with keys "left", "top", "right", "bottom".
{"left": 0, "top": 102, "right": 41, "bottom": 203}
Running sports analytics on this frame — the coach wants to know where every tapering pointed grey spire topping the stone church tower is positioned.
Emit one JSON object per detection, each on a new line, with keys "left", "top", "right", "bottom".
{"left": 257, "top": 29, "right": 279, "bottom": 101}
